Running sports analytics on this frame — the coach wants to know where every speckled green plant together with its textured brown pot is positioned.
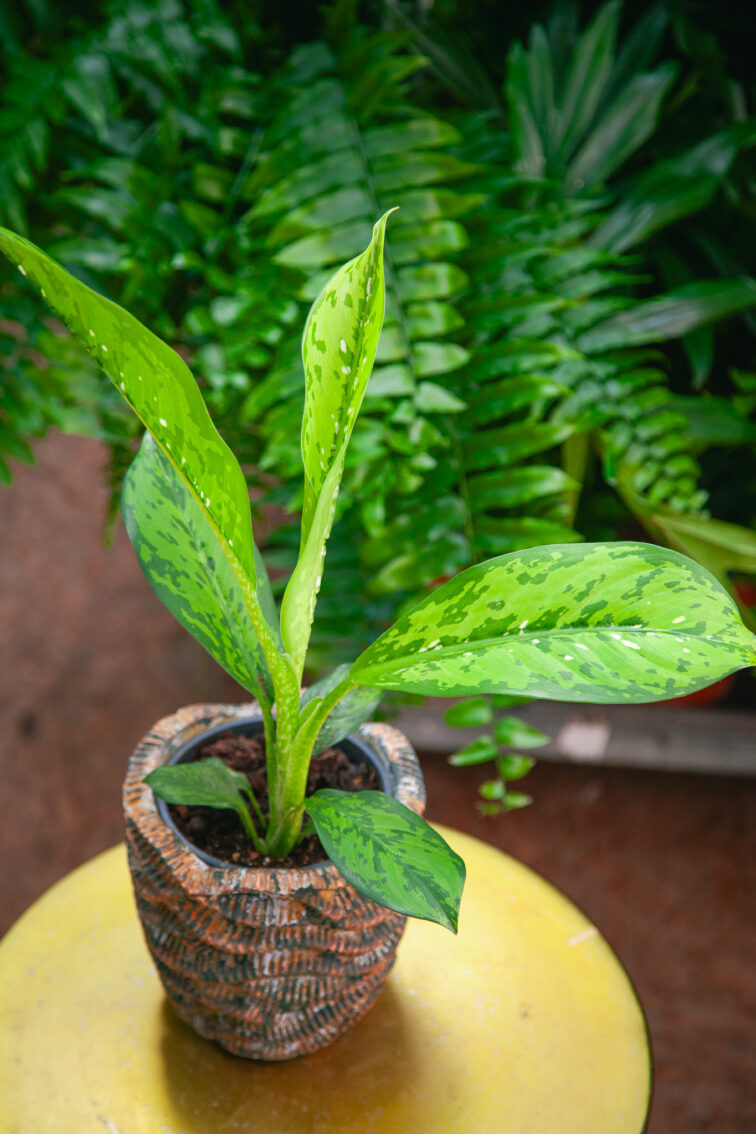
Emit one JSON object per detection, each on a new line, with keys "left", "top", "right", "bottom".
{"left": 0, "top": 214, "right": 755, "bottom": 1059}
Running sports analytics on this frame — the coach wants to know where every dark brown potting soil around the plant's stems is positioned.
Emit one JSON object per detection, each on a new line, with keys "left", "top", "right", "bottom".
{"left": 168, "top": 733, "right": 381, "bottom": 866}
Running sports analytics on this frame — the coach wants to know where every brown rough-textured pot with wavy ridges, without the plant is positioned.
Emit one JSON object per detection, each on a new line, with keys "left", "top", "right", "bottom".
{"left": 124, "top": 705, "right": 425, "bottom": 1059}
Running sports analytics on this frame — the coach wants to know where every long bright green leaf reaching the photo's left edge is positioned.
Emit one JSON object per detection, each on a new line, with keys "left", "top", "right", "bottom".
{"left": 0, "top": 228, "right": 255, "bottom": 587}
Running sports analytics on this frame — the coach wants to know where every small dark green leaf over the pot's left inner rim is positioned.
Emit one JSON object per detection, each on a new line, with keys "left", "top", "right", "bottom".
{"left": 144, "top": 756, "right": 258, "bottom": 845}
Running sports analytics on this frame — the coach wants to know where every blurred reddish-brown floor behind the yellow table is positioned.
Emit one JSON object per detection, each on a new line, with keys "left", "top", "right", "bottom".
{"left": 0, "top": 437, "right": 756, "bottom": 1134}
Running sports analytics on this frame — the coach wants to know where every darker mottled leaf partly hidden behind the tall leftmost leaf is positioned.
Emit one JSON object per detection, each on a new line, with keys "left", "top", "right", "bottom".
{"left": 121, "top": 433, "right": 275, "bottom": 699}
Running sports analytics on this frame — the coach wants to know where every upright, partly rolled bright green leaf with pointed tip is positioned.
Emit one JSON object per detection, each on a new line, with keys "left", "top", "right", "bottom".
{"left": 281, "top": 213, "right": 389, "bottom": 669}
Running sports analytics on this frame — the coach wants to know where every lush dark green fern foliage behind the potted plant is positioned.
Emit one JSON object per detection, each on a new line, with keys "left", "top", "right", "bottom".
{"left": 0, "top": 0, "right": 756, "bottom": 661}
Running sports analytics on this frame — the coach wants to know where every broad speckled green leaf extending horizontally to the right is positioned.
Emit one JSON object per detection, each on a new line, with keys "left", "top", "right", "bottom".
{"left": 351, "top": 543, "right": 756, "bottom": 703}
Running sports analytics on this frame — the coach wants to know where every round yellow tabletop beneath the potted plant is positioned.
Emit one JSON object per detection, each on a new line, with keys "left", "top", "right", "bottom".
{"left": 0, "top": 829, "right": 651, "bottom": 1134}
